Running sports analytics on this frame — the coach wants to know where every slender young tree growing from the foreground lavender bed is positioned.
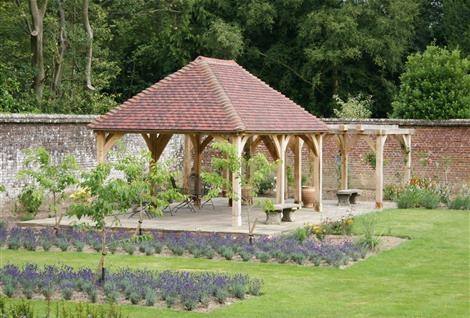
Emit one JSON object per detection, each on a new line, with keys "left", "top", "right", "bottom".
{"left": 68, "top": 163, "right": 130, "bottom": 282}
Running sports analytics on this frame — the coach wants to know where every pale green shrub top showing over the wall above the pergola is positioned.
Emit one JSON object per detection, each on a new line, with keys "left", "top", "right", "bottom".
{"left": 333, "top": 94, "right": 372, "bottom": 119}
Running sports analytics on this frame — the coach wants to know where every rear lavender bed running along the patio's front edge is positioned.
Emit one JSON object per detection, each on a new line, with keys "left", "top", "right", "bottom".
{"left": 0, "top": 227, "right": 368, "bottom": 266}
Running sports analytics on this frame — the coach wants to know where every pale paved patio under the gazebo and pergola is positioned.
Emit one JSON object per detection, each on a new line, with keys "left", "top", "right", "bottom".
{"left": 20, "top": 198, "right": 395, "bottom": 235}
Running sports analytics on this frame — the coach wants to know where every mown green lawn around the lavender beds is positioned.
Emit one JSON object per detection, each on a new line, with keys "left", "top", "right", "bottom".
{"left": 0, "top": 209, "right": 470, "bottom": 317}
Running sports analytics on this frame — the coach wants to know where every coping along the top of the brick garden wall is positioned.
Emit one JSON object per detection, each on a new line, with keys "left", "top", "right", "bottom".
{"left": 0, "top": 114, "right": 470, "bottom": 127}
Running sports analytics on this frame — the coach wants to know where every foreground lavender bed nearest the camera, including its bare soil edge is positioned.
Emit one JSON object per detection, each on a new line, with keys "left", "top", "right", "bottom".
{"left": 0, "top": 264, "right": 262, "bottom": 310}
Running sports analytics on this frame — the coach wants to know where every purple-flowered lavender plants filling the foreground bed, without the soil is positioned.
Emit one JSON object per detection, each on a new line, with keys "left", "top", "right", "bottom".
{"left": 0, "top": 264, "right": 261, "bottom": 310}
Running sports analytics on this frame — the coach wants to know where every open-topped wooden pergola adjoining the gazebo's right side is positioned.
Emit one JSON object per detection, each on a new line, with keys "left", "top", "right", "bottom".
{"left": 328, "top": 124, "right": 414, "bottom": 209}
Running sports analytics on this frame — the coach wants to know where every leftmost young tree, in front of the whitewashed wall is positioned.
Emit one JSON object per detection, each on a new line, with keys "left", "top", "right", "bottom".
{"left": 18, "top": 147, "right": 78, "bottom": 232}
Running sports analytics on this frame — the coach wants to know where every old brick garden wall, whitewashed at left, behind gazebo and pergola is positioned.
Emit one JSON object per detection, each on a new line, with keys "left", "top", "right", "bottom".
{"left": 0, "top": 114, "right": 470, "bottom": 211}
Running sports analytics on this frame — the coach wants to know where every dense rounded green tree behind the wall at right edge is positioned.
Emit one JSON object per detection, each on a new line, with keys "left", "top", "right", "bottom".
{"left": 393, "top": 45, "right": 470, "bottom": 119}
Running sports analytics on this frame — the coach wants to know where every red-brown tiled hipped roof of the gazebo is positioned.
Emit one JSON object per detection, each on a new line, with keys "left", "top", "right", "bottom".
{"left": 89, "top": 56, "right": 328, "bottom": 133}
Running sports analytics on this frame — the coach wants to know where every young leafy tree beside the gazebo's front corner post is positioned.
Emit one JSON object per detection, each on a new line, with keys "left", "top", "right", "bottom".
{"left": 202, "top": 142, "right": 277, "bottom": 243}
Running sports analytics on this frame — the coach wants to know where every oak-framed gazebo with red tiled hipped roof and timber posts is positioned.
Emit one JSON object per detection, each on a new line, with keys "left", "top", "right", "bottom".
{"left": 89, "top": 56, "right": 328, "bottom": 226}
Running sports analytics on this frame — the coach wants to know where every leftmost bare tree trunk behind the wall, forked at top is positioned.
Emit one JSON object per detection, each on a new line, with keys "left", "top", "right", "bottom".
{"left": 29, "top": 0, "right": 47, "bottom": 101}
